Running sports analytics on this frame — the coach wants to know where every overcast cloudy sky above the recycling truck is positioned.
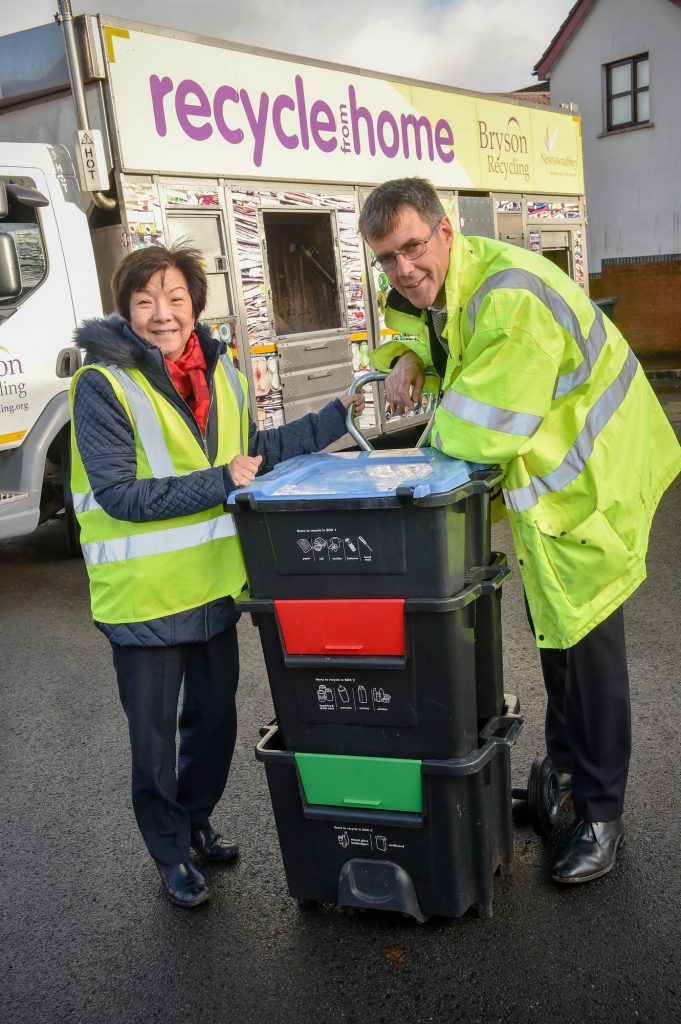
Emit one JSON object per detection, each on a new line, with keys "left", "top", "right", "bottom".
{"left": 0, "top": 0, "right": 573, "bottom": 92}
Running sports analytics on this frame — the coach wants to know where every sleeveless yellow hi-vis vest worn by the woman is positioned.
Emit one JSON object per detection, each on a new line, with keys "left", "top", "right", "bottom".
{"left": 71, "top": 355, "right": 249, "bottom": 625}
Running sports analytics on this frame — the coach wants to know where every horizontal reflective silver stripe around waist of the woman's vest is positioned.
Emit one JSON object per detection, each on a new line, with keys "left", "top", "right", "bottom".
{"left": 83, "top": 515, "right": 237, "bottom": 565}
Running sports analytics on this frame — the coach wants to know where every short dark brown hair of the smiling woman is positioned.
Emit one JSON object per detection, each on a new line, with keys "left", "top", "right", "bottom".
{"left": 112, "top": 243, "right": 208, "bottom": 321}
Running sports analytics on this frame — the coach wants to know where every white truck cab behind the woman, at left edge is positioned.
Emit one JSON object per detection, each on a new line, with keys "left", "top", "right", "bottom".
{"left": 0, "top": 142, "right": 101, "bottom": 555}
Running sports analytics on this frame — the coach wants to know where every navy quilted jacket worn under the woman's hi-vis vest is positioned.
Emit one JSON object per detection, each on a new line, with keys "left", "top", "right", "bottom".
{"left": 74, "top": 316, "right": 345, "bottom": 646}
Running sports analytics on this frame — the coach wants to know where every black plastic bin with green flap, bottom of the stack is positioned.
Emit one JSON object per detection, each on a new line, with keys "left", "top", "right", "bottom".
{"left": 256, "top": 716, "right": 522, "bottom": 922}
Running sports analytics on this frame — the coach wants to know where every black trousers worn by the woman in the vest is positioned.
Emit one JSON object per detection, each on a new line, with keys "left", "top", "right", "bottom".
{"left": 113, "top": 626, "right": 239, "bottom": 864}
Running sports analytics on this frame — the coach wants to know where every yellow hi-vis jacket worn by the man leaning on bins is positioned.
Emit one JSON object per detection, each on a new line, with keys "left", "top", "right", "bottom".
{"left": 373, "top": 234, "right": 681, "bottom": 648}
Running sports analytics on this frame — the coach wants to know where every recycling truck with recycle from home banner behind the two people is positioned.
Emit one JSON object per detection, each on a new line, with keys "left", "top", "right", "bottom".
{"left": 0, "top": 8, "right": 588, "bottom": 538}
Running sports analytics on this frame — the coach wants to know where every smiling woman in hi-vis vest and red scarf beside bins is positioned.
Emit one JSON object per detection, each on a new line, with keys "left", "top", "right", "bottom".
{"left": 71, "top": 246, "right": 364, "bottom": 907}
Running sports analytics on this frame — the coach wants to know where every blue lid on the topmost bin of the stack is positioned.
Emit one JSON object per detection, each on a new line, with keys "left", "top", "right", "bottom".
{"left": 227, "top": 447, "right": 488, "bottom": 508}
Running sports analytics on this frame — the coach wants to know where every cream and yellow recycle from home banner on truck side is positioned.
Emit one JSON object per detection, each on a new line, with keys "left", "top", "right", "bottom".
{"left": 104, "top": 27, "right": 584, "bottom": 196}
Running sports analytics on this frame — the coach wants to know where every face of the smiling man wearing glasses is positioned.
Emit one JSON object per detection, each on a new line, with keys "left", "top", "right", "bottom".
{"left": 367, "top": 205, "right": 454, "bottom": 309}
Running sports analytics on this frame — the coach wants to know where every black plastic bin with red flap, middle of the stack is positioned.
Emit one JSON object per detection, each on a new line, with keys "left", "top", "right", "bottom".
{"left": 236, "top": 554, "right": 510, "bottom": 758}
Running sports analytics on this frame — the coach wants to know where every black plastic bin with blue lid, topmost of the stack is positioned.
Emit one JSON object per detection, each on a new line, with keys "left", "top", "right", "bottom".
{"left": 228, "top": 449, "right": 503, "bottom": 599}
